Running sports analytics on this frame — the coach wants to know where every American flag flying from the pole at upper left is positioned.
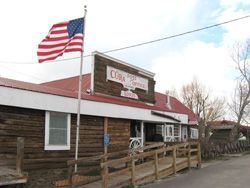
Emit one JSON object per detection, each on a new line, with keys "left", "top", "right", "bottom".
{"left": 37, "top": 18, "right": 84, "bottom": 63}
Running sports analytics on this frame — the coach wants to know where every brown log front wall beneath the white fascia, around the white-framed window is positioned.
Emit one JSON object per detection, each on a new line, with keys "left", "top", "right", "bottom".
{"left": 0, "top": 105, "right": 130, "bottom": 171}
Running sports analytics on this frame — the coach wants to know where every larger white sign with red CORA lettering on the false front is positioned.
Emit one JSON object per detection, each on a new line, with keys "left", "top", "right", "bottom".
{"left": 107, "top": 66, "right": 148, "bottom": 91}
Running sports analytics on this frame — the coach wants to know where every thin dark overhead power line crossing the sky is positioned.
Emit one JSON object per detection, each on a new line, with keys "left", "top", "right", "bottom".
{"left": 0, "top": 15, "right": 250, "bottom": 64}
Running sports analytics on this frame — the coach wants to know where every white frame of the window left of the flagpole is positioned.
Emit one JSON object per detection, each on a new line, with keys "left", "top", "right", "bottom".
{"left": 44, "top": 111, "right": 71, "bottom": 150}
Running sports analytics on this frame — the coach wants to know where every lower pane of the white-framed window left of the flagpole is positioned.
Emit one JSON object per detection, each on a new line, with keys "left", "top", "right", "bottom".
{"left": 49, "top": 128, "right": 67, "bottom": 145}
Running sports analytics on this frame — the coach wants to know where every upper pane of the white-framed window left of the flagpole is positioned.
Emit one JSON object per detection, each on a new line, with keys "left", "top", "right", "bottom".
{"left": 49, "top": 112, "right": 67, "bottom": 129}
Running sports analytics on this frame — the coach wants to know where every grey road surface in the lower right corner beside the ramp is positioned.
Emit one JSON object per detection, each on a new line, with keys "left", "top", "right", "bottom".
{"left": 143, "top": 154, "right": 250, "bottom": 188}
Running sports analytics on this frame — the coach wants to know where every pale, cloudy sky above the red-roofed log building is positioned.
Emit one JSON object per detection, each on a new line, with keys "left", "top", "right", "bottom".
{"left": 0, "top": 0, "right": 250, "bottom": 100}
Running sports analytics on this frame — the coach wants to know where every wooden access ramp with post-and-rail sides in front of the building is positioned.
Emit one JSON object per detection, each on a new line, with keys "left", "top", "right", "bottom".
{"left": 58, "top": 142, "right": 201, "bottom": 188}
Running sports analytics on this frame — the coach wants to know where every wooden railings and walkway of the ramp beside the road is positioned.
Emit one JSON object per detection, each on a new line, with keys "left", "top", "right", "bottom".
{"left": 60, "top": 142, "right": 201, "bottom": 188}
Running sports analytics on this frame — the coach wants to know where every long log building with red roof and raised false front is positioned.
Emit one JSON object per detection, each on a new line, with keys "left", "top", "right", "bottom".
{"left": 0, "top": 52, "right": 198, "bottom": 182}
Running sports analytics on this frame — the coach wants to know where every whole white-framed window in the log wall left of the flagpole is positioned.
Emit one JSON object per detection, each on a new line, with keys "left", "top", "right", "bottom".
{"left": 45, "top": 112, "right": 71, "bottom": 150}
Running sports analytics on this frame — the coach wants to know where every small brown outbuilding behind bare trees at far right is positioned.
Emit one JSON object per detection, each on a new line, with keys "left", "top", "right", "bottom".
{"left": 207, "top": 120, "right": 250, "bottom": 143}
